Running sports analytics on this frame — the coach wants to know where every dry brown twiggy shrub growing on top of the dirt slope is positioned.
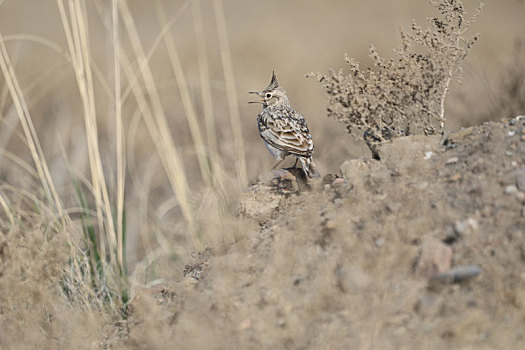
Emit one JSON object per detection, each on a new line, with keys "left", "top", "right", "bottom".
{"left": 309, "top": 0, "right": 482, "bottom": 159}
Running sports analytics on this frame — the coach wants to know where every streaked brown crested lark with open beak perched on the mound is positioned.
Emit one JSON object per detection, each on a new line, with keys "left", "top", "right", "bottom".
{"left": 250, "top": 72, "right": 320, "bottom": 178}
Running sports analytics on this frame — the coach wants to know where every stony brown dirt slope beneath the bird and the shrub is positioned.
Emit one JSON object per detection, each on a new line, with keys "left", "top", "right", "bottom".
{"left": 104, "top": 118, "right": 525, "bottom": 349}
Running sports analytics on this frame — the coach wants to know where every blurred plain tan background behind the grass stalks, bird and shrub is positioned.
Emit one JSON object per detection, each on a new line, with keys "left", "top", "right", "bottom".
{"left": 0, "top": 0, "right": 525, "bottom": 262}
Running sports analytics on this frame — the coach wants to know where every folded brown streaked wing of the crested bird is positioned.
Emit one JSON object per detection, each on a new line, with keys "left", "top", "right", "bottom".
{"left": 259, "top": 110, "right": 314, "bottom": 157}
